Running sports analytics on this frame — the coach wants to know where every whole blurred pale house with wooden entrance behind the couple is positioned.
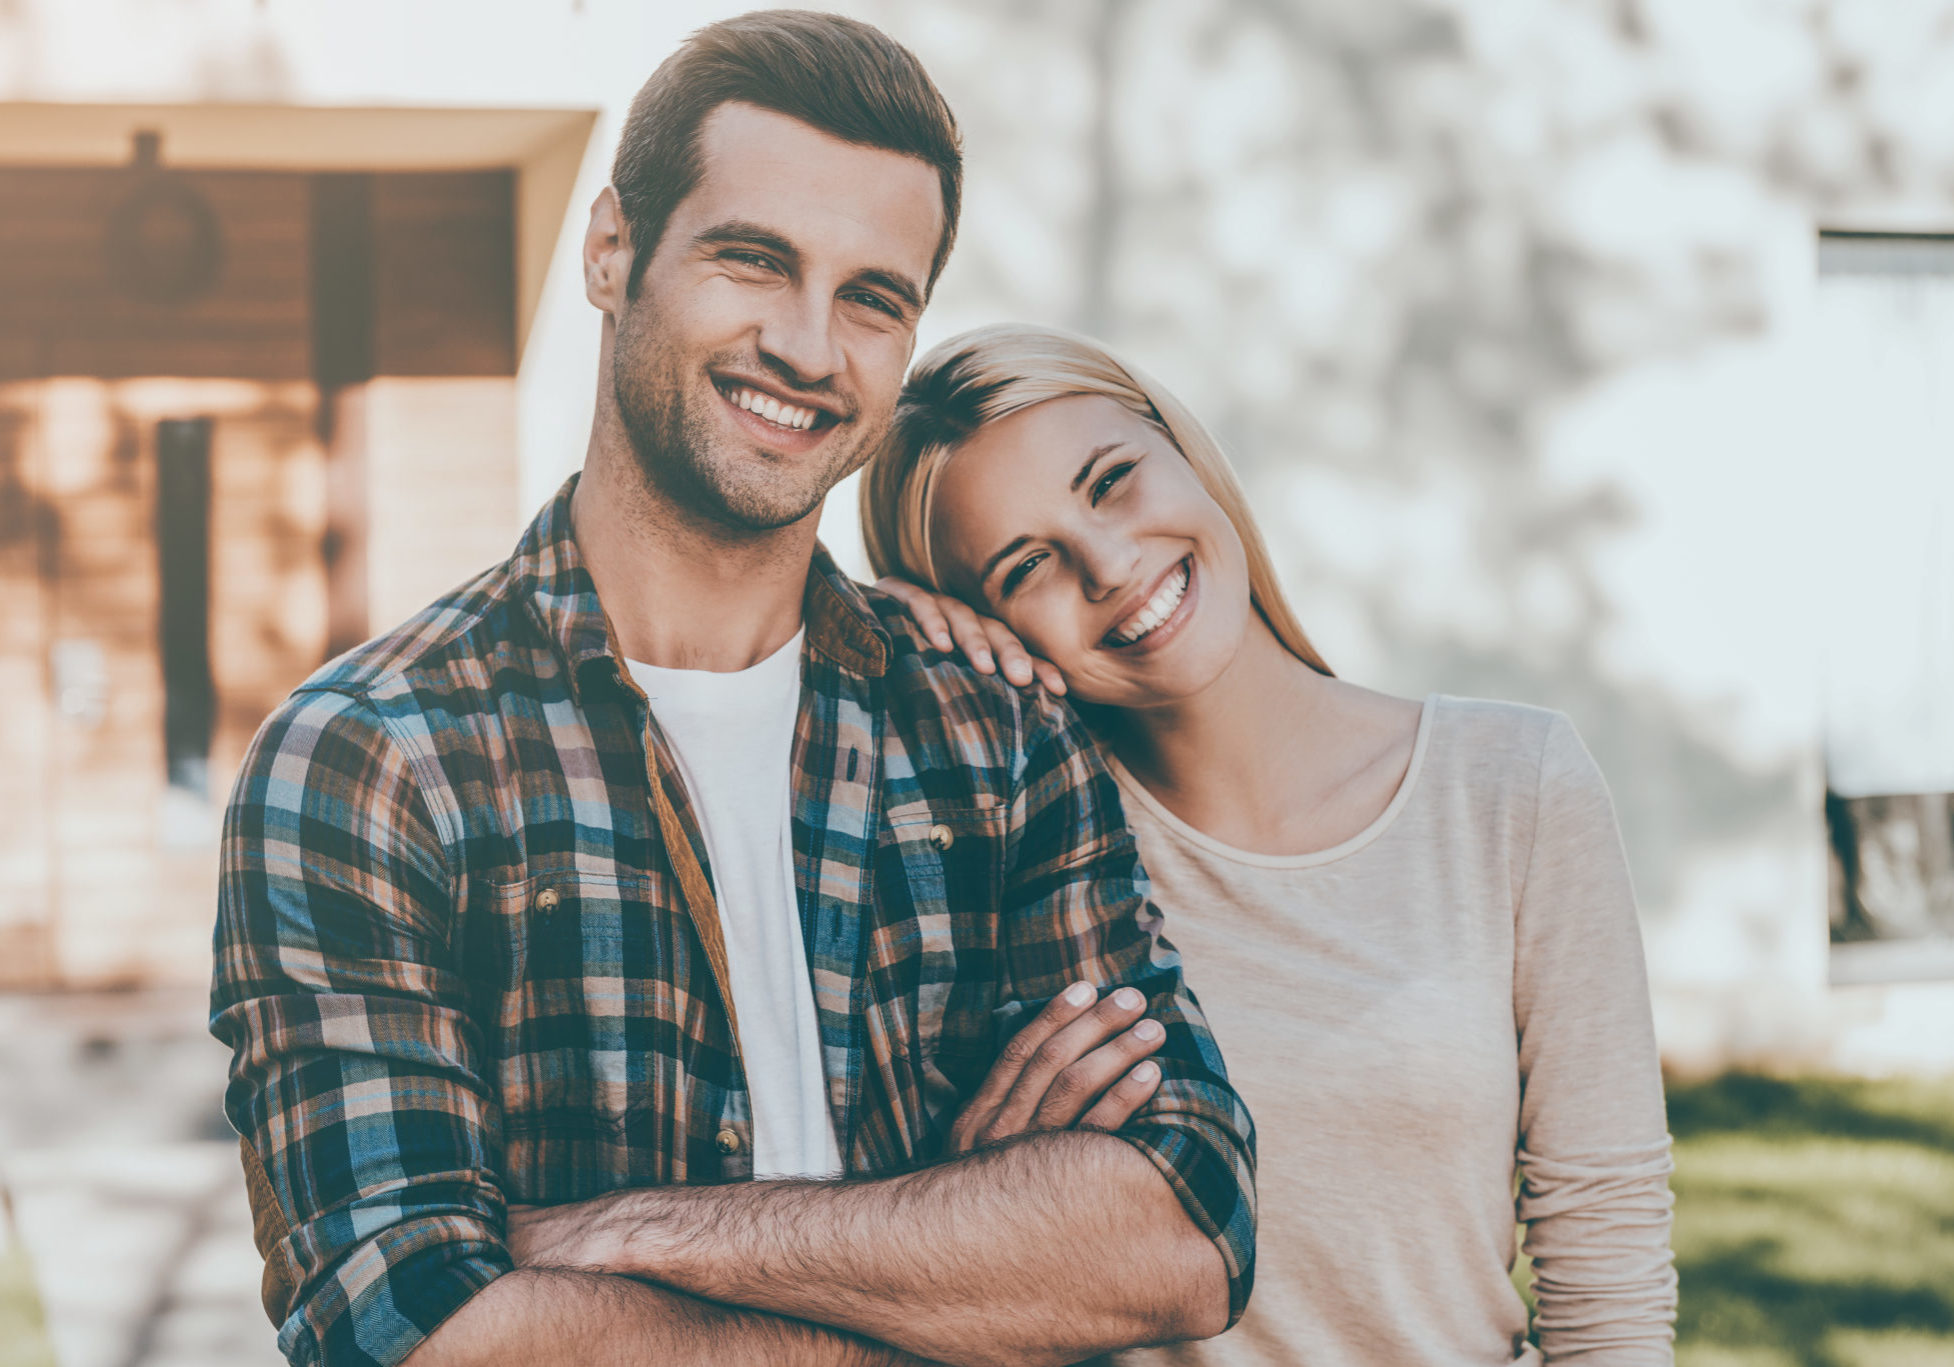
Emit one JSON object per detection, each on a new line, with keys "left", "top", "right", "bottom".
{"left": 0, "top": 0, "right": 1954, "bottom": 1070}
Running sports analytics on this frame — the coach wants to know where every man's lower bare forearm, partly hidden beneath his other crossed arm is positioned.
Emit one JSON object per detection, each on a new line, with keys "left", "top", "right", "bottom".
{"left": 406, "top": 1269, "right": 926, "bottom": 1367}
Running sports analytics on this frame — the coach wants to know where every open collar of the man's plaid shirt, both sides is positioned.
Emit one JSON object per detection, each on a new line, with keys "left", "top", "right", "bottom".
{"left": 508, "top": 475, "right": 889, "bottom": 705}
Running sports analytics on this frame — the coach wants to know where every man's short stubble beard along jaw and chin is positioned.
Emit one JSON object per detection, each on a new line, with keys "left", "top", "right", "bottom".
{"left": 612, "top": 303, "right": 889, "bottom": 533}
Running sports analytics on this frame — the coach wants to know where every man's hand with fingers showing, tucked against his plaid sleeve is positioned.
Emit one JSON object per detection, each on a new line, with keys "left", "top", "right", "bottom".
{"left": 950, "top": 982, "right": 1167, "bottom": 1154}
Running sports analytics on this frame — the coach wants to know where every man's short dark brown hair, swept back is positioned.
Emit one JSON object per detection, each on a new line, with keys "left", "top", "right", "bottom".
{"left": 612, "top": 10, "right": 963, "bottom": 293}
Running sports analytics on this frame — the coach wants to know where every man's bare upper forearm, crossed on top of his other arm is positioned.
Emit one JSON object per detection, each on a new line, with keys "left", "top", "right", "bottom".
{"left": 518, "top": 1133, "right": 1227, "bottom": 1367}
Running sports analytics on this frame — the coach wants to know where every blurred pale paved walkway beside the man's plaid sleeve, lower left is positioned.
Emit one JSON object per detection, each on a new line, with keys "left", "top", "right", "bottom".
{"left": 0, "top": 990, "right": 283, "bottom": 1367}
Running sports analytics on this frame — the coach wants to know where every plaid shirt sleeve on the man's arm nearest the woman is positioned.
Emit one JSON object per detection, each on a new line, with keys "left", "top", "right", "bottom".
{"left": 1002, "top": 693, "right": 1254, "bottom": 1324}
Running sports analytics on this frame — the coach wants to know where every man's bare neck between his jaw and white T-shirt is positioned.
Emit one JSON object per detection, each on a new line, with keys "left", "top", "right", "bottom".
{"left": 571, "top": 434, "right": 821, "bottom": 674}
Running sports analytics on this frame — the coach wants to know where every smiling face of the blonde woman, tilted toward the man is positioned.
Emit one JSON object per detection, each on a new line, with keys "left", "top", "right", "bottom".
{"left": 930, "top": 394, "right": 1253, "bottom": 707}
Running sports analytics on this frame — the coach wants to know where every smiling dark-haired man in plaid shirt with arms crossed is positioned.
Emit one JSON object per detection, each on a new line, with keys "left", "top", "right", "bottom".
{"left": 213, "top": 12, "right": 1253, "bottom": 1367}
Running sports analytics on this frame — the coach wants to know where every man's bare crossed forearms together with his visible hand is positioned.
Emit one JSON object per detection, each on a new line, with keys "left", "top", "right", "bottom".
{"left": 410, "top": 990, "right": 1229, "bottom": 1367}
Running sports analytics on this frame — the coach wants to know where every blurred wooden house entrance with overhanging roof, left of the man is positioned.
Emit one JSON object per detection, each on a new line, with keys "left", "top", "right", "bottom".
{"left": 0, "top": 102, "right": 590, "bottom": 986}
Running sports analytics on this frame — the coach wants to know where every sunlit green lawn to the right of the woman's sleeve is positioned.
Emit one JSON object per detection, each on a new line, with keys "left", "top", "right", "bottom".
{"left": 1669, "top": 1074, "right": 1954, "bottom": 1367}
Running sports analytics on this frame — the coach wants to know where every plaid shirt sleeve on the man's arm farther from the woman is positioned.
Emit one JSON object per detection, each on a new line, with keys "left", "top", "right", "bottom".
{"left": 211, "top": 691, "right": 510, "bottom": 1367}
